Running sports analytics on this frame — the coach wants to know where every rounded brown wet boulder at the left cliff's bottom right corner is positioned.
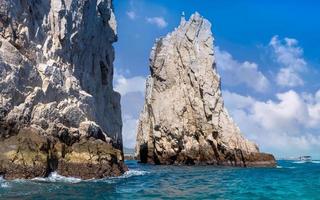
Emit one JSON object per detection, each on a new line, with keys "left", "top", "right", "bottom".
{"left": 57, "top": 138, "right": 127, "bottom": 179}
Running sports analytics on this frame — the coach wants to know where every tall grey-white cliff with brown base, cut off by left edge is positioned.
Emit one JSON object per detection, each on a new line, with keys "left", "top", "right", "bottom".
{"left": 0, "top": 0, "right": 126, "bottom": 179}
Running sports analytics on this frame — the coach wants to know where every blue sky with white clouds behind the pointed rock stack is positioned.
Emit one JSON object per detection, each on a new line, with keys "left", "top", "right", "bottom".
{"left": 114, "top": 0, "right": 320, "bottom": 159}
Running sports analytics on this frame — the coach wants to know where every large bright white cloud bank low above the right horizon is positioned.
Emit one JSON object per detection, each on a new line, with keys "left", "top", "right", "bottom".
{"left": 223, "top": 90, "right": 320, "bottom": 157}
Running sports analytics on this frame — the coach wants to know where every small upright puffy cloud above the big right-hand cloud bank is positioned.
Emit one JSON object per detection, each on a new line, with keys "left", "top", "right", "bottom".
{"left": 269, "top": 36, "right": 307, "bottom": 87}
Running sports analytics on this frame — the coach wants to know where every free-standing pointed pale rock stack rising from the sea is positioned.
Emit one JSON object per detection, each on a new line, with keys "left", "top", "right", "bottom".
{"left": 136, "top": 13, "right": 275, "bottom": 166}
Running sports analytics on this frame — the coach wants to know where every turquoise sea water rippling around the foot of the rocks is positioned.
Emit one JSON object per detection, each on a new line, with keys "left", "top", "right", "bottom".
{"left": 0, "top": 161, "right": 320, "bottom": 200}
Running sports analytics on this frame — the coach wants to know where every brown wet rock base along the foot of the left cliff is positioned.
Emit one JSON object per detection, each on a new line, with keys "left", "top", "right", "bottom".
{"left": 0, "top": 127, "right": 127, "bottom": 179}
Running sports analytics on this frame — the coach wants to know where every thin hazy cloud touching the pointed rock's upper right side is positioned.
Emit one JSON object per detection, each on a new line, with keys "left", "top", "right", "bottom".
{"left": 215, "top": 47, "right": 269, "bottom": 92}
